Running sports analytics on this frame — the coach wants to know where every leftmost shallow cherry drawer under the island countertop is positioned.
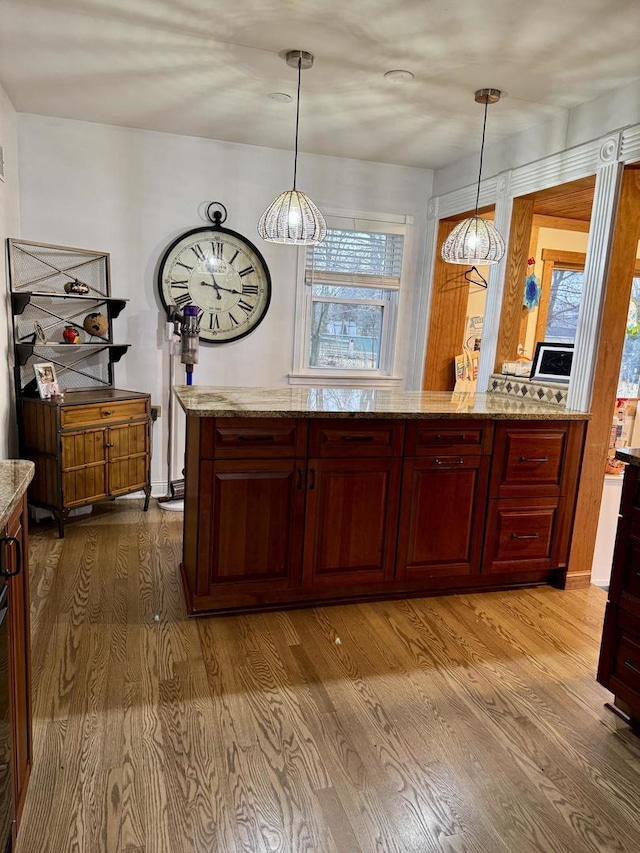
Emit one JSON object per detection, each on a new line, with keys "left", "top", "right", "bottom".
{"left": 200, "top": 418, "right": 306, "bottom": 459}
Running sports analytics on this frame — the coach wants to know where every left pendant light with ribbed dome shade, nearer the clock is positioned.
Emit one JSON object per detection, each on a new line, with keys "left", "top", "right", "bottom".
{"left": 258, "top": 50, "right": 327, "bottom": 246}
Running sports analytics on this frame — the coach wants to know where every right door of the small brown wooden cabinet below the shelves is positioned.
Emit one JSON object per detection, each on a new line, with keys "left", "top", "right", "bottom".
{"left": 106, "top": 421, "right": 149, "bottom": 495}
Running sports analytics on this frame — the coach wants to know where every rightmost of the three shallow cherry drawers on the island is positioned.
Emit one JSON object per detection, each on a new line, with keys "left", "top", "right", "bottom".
{"left": 405, "top": 421, "right": 493, "bottom": 456}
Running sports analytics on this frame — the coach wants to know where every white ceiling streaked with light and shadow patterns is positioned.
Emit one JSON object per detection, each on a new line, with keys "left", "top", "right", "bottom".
{"left": 0, "top": 0, "right": 640, "bottom": 169}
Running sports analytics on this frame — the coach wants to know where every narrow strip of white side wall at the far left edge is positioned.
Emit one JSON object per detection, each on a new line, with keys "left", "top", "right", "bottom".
{"left": 0, "top": 87, "right": 19, "bottom": 459}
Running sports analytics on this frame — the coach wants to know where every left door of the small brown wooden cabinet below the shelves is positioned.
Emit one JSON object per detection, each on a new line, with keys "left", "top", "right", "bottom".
{"left": 61, "top": 429, "right": 107, "bottom": 507}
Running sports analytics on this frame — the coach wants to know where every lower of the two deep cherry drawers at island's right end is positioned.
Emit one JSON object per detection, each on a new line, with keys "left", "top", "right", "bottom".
{"left": 483, "top": 498, "right": 560, "bottom": 572}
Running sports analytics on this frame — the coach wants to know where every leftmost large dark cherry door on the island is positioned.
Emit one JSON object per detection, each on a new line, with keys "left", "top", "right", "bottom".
{"left": 197, "top": 459, "right": 305, "bottom": 596}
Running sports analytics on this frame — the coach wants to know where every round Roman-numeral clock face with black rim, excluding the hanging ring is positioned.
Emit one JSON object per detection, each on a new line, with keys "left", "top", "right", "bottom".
{"left": 158, "top": 228, "right": 271, "bottom": 344}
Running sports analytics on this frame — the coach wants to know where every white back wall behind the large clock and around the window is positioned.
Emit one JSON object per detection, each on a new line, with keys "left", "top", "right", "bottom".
{"left": 18, "top": 115, "right": 433, "bottom": 482}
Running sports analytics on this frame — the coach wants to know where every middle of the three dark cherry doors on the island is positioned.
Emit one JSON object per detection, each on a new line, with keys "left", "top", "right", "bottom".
{"left": 304, "top": 459, "right": 401, "bottom": 586}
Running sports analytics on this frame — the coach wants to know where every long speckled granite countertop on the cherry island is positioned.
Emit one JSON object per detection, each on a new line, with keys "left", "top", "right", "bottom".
{"left": 175, "top": 385, "right": 590, "bottom": 421}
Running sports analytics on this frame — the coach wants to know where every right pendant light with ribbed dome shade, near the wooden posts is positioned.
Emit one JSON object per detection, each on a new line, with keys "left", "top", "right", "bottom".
{"left": 441, "top": 89, "right": 504, "bottom": 266}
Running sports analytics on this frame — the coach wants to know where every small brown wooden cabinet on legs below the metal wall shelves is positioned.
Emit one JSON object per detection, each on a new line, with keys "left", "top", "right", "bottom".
{"left": 20, "top": 388, "right": 151, "bottom": 536}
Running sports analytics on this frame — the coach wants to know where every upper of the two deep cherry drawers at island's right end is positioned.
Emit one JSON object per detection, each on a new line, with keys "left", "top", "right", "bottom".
{"left": 490, "top": 424, "right": 568, "bottom": 498}
